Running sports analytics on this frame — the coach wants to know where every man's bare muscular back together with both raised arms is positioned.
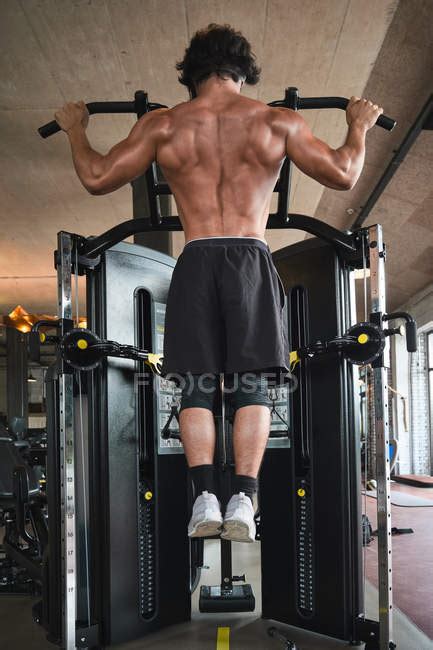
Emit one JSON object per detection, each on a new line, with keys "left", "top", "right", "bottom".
{"left": 66, "top": 81, "right": 370, "bottom": 229}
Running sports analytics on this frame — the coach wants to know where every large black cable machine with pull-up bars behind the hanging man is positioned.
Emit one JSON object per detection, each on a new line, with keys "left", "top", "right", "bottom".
{"left": 24, "top": 88, "right": 414, "bottom": 650}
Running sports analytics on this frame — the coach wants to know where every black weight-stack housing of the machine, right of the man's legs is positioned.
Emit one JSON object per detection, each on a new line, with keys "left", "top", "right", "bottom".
{"left": 260, "top": 240, "right": 363, "bottom": 641}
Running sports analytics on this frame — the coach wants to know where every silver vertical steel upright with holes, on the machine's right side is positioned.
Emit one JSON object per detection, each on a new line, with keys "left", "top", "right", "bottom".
{"left": 368, "top": 225, "right": 395, "bottom": 650}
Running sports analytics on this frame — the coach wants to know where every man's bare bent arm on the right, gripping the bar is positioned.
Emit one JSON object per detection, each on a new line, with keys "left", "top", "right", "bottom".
{"left": 286, "top": 97, "right": 383, "bottom": 190}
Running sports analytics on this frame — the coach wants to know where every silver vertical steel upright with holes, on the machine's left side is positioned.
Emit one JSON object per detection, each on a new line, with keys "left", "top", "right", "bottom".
{"left": 57, "top": 232, "right": 77, "bottom": 650}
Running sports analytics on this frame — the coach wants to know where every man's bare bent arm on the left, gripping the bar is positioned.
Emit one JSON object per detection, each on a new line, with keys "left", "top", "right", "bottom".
{"left": 55, "top": 102, "right": 160, "bottom": 194}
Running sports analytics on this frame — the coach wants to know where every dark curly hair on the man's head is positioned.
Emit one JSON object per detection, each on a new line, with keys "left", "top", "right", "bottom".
{"left": 176, "top": 23, "right": 260, "bottom": 97}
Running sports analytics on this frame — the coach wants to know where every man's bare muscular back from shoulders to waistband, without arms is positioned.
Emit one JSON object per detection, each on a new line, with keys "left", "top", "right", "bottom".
{"left": 156, "top": 94, "right": 286, "bottom": 241}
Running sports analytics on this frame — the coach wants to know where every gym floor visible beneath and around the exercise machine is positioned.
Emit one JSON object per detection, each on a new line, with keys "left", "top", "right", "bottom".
{"left": 0, "top": 484, "right": 433, "bottom": 650}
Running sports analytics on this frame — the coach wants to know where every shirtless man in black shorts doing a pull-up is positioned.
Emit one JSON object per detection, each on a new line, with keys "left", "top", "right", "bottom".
{"left": 55, "top": 24, "right": 383, "bottom": 541}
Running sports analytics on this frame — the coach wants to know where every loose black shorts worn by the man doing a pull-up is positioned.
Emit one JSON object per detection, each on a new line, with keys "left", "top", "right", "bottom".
{"left": 162, "top": 237, "right": 289, "bottom": 385}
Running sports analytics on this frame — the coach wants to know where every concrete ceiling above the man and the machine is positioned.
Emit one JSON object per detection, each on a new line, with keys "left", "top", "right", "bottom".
{"left": 0, "top": 0, "right": 433, "bottom": 314}
